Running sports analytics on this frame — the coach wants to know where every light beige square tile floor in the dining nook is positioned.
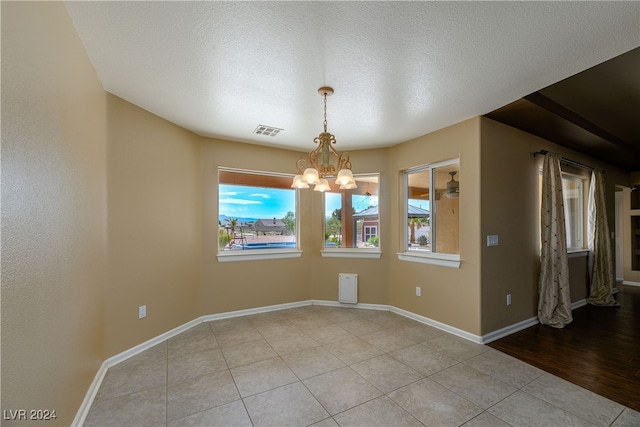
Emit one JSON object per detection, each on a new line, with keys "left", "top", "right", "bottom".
{"left": 84, "top": 305, "right": 640, "bottom": 427}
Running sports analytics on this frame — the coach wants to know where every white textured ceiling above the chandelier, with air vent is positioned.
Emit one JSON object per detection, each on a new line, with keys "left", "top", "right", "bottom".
{"left": 66, "top": 1, "right": 640, "bottom": 151}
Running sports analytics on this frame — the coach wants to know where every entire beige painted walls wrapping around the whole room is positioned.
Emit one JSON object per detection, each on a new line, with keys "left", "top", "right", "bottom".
{"left": 1, "top": 2, "right": 629, "bottom": 425}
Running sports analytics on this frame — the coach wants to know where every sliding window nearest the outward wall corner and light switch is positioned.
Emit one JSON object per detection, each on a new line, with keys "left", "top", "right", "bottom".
{"left": 404, "top": 159, "right": 460, "bottom": 262}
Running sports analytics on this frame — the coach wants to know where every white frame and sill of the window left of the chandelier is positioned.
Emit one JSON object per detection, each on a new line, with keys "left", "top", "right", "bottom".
{"left": 216, "top": 166, "right": 302, "bottom": 262}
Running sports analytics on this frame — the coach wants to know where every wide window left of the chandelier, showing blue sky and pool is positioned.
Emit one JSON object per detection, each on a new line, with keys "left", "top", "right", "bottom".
{"left": 218, "top": 169, "right": 298, "bottom": 255}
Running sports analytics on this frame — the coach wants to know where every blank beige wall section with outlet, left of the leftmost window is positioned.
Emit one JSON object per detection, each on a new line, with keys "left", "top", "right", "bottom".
{"left": 104, "top": 95, "right": 202, "bottom": 357}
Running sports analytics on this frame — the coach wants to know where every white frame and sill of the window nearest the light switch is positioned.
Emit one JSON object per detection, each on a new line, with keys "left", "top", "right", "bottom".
{"left": 397, "top": 157, "right": 461, "bottom": 268}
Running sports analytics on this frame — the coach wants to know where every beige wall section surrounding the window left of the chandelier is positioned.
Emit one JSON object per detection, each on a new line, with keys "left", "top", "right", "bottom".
{"left": 199, "top": 138, "right": 312, "bottom": 315}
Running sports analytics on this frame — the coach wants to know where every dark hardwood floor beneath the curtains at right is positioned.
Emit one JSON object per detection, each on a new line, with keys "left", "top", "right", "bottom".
{"left": 489, "top": 285, "right": 640, "bottom": 411}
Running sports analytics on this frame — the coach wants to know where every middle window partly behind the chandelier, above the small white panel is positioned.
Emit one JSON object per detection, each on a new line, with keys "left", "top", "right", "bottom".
{"left": 324, "top": 175, "right": 380, "bottom": 250}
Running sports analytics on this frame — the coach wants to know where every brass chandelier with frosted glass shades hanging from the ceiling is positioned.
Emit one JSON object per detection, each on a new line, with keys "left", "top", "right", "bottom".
{"left": 291, "top": 87, "right": 358, "bottom": 191}
